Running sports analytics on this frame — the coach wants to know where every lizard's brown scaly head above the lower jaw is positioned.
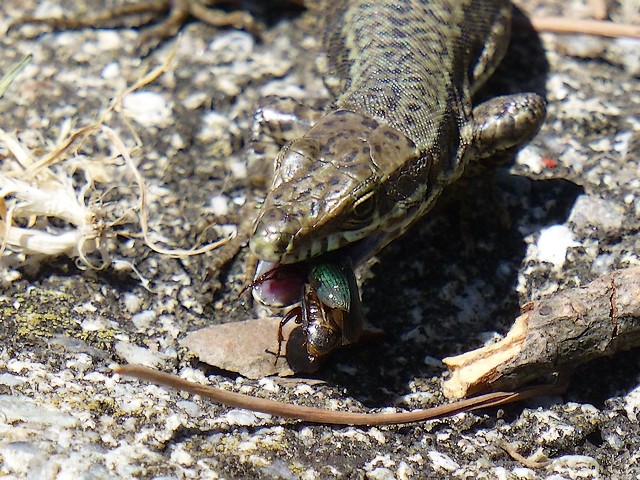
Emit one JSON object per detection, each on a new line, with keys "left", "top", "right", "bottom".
{"left": 250, "top": 110, "right": 429, "bottom": 263}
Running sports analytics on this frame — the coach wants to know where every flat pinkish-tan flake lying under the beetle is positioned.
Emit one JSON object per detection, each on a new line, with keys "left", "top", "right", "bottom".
{"left": 180, "top": 317, "right": 319, "bottom": 379}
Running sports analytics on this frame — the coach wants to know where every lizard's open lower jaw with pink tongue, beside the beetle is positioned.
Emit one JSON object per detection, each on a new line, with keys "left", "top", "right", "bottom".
{"left": 251, "top": 232, "right": 386, "bottom": 308}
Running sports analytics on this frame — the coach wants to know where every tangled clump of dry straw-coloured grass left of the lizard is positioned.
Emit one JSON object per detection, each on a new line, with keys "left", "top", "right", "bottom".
{"left": 0, "top": 46, "right": 235, "bottom": 284}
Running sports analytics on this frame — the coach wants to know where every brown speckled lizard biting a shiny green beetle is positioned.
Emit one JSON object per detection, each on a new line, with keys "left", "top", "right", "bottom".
{"left": 249, "top": 0, "right": 546, "bottom": 356}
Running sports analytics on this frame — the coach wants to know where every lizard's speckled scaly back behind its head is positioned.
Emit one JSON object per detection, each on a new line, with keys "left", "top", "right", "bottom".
{"left": 323, "top": 0, "right": 510, "bottom": 150}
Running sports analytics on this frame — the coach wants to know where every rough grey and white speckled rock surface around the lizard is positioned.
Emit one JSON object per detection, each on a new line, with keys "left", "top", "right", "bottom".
{"left": 0, "top": 0, "right": 640, "bottom": 479}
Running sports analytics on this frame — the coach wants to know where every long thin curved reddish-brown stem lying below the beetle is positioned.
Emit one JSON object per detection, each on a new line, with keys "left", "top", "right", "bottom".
{"left": 115, "top": 365, "right": 564, "bottom": 425}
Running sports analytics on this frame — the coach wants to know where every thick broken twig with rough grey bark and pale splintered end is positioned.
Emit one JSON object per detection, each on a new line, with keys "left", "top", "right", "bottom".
{"left": 443, "top": 267, "right": 640, "bottom": 398}
